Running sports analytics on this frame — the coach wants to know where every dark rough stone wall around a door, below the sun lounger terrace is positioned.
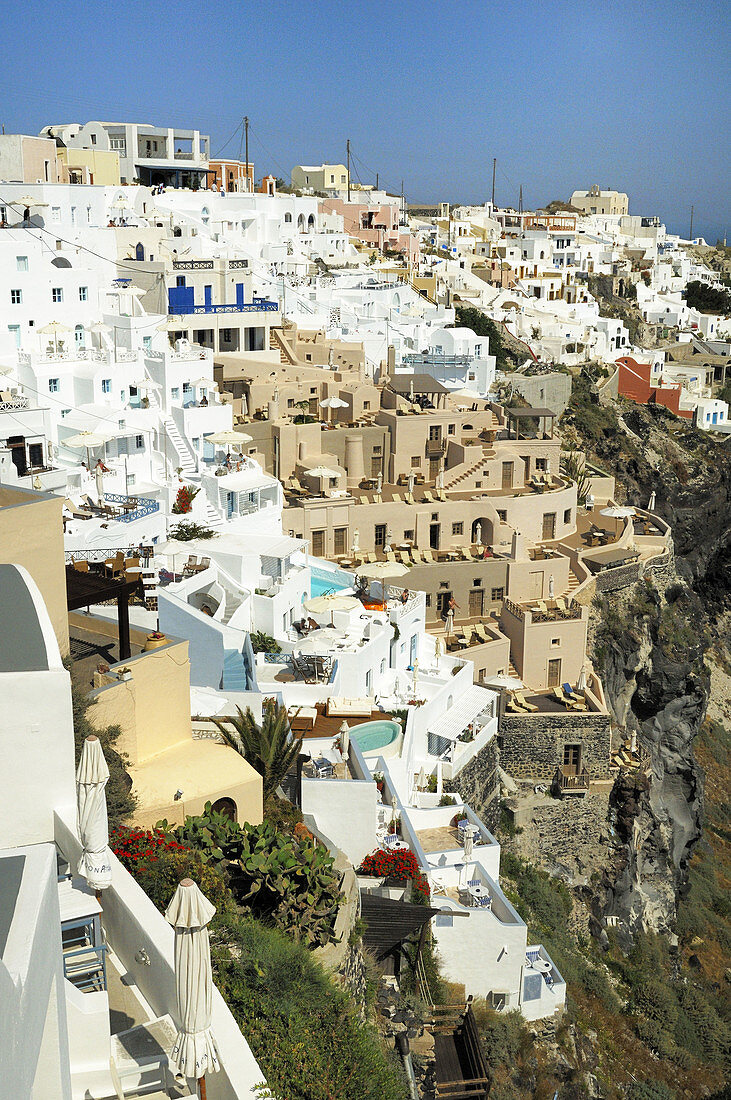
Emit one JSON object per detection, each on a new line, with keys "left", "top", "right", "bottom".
{"left": 498, "top": 712, "right": 611, "bottom": 782}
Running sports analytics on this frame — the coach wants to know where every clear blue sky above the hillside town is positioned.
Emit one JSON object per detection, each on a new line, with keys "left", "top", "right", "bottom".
{"left": 0, "top": 0, "right": 731, "bottom": 241}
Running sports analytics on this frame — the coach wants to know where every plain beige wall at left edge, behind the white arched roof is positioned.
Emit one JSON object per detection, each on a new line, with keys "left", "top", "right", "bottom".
{"left": 0, "top": 485, "right": 68, "bottom": 657}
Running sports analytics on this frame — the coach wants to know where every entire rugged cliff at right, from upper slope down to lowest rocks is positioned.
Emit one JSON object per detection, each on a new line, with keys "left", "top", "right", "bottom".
{"left": 575, "top": 393, "right": 731, "bottom": 938}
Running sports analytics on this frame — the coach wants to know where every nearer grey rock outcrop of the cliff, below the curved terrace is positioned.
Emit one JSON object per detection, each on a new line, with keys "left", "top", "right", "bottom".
{"left": 596, "top": 596, "right": 708, "bottom": 936}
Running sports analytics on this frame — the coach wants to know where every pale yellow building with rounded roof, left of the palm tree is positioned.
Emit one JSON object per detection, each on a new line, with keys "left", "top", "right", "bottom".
{"left": 89, "top": 639, "right": 263, "bottom": 828}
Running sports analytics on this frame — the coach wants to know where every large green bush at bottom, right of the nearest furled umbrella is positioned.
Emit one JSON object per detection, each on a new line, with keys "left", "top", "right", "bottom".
{"left": 211, "top": 916, "right": 408, "bottom": 1100}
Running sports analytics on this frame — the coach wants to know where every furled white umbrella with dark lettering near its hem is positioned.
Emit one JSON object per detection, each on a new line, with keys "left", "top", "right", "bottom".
{"left": 76, "top": 734, "right": 112, "bottom": 890}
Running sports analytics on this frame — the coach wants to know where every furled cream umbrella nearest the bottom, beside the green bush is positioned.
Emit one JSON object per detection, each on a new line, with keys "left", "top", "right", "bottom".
{"left": 165, "top": 879, "right": 221, "bottom": 1100}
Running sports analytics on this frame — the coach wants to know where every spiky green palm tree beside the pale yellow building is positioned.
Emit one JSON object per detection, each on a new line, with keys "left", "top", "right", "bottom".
{"left": 213, "top": 699, "right": 303, "bottom": 802}
